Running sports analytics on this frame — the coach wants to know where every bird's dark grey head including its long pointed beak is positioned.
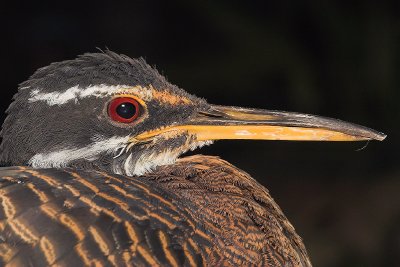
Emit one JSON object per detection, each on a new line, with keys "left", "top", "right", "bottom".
{"left": 0, "top": 51, "right": 385, "bottom": 176}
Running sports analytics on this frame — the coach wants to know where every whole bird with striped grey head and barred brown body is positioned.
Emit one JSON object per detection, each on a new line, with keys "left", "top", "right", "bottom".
{"left": 0, "top": 50, "right": 386, "bottom": 266}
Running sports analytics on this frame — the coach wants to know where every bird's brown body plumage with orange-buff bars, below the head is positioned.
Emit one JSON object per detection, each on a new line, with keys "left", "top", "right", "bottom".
{"left": 0, "top": 156, "right": 311, "bottom": 266}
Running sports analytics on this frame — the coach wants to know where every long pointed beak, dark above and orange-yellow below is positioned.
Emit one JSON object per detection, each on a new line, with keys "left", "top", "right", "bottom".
{"left": 135, "top": 105, "right": 386, "bottom": 141}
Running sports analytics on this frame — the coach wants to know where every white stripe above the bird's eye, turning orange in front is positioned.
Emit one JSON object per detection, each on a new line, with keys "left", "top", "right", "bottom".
{"left": 28, "top": 84, "right": 152, "bottom": 106}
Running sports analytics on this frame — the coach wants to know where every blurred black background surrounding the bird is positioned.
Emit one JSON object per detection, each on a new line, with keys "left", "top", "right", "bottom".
{"left": 0, "top": 0, "right": 400, "bottom": 266}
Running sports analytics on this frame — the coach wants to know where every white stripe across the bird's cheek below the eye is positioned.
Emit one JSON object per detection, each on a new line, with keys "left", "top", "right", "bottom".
{"left": 29, "top": 136, "right": 130, "bottom": 168}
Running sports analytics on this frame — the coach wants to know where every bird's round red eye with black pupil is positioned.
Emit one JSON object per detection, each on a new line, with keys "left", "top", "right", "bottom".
{"left": 108, "top": 97, "right": 139, "bottom": 123}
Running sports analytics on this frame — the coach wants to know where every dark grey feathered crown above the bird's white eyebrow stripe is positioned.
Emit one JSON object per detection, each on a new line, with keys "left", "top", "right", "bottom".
{"left": 20, "top": 51, "right": 176, "bottom": 94}
